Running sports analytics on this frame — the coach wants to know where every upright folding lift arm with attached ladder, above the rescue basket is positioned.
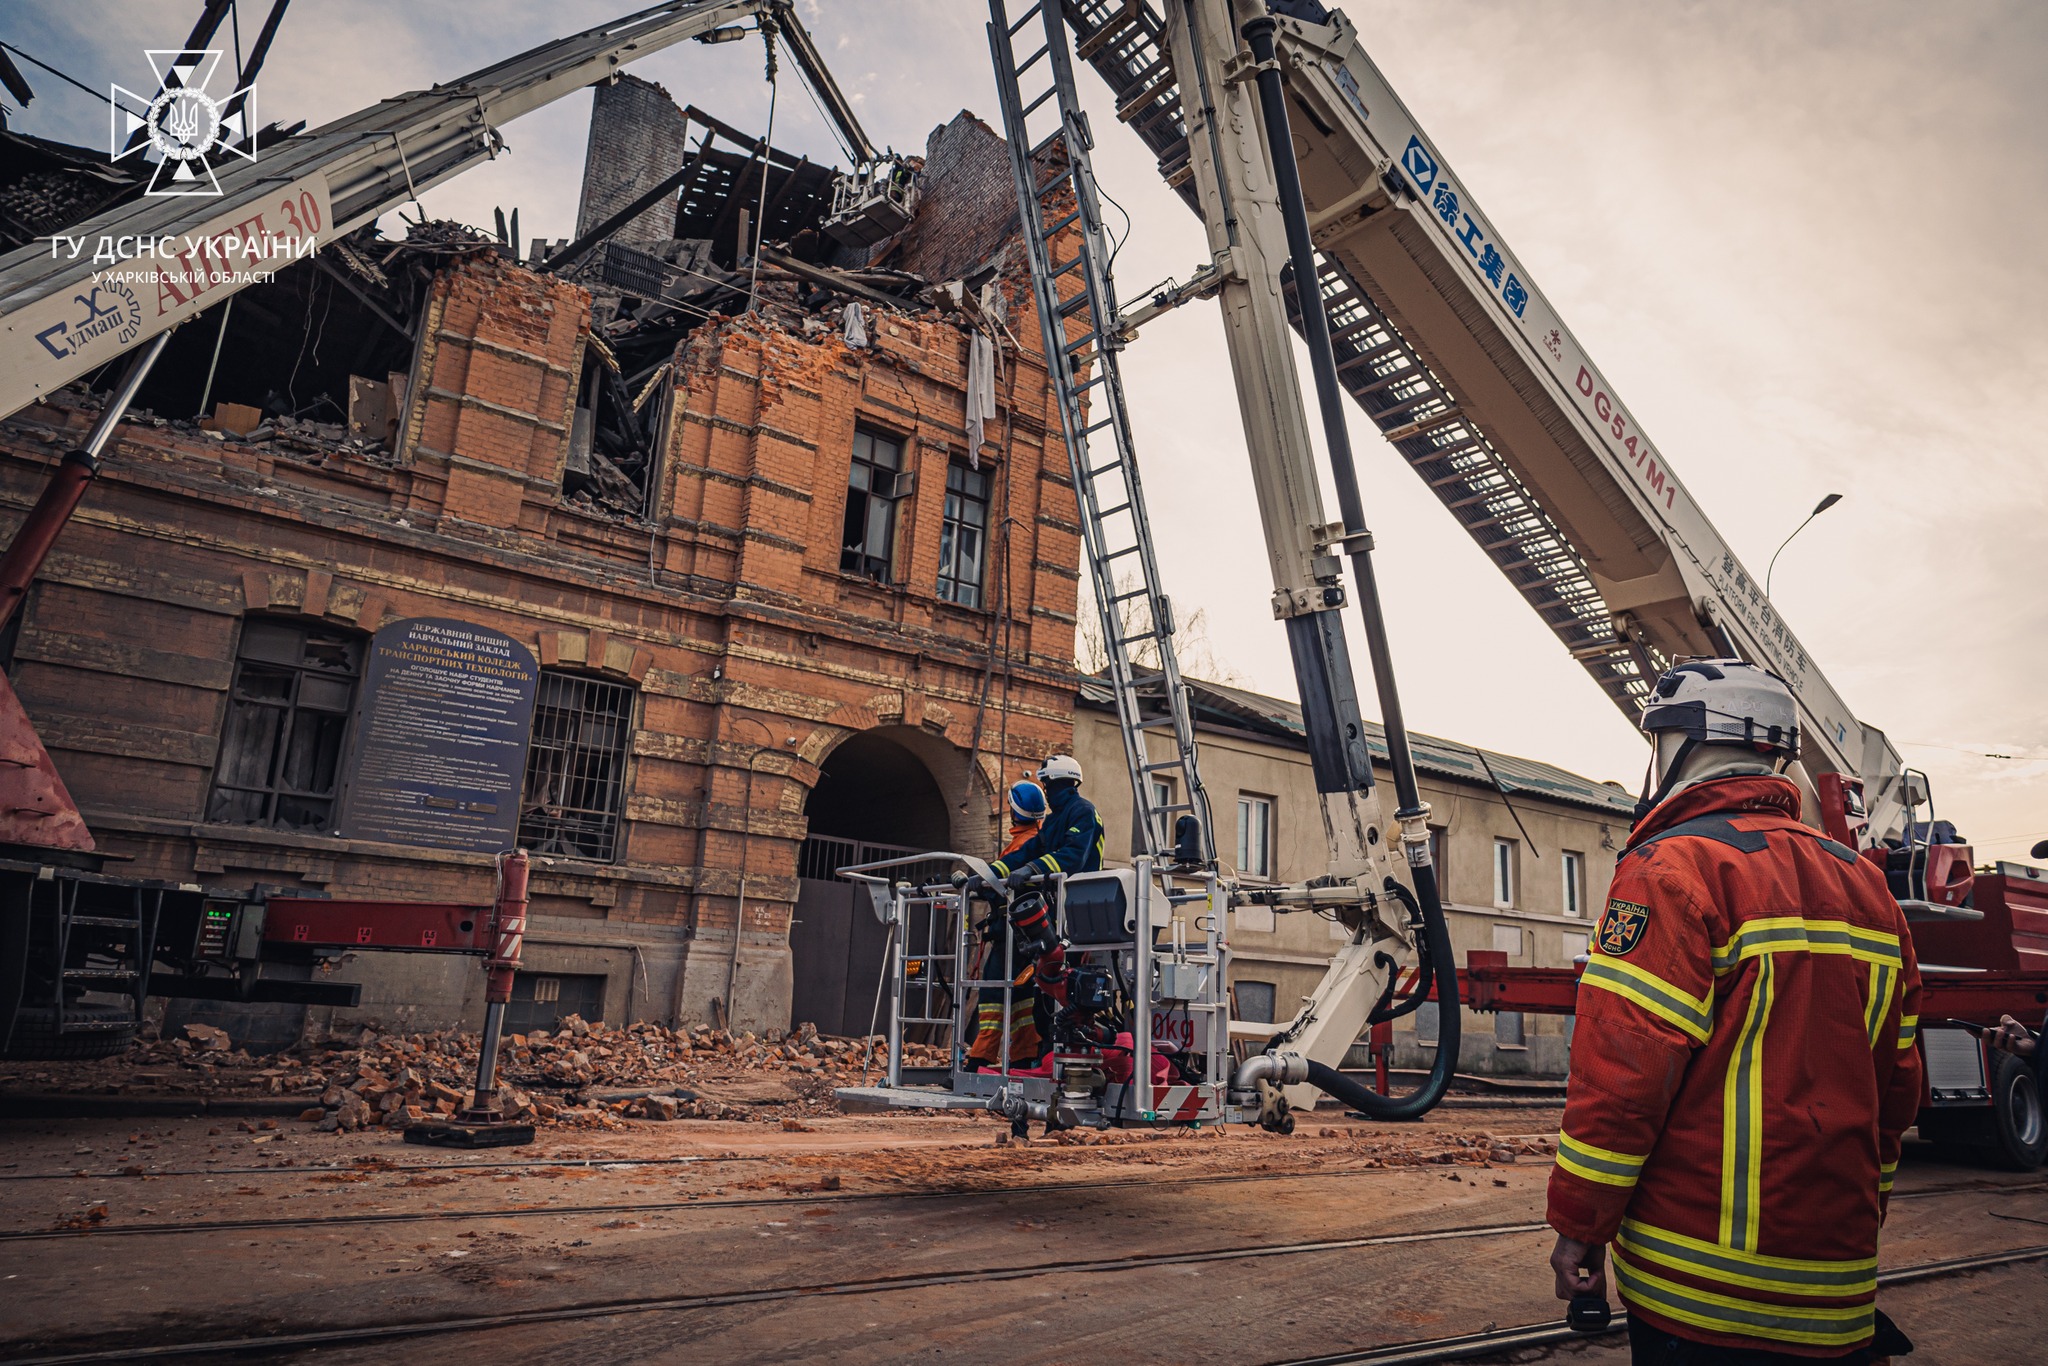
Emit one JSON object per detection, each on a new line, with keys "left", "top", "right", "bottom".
{"left": 989, "top": 0, "right": 1458, "bottom": 1122}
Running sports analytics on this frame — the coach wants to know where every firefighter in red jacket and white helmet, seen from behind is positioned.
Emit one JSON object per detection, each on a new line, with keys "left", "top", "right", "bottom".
{"left": 1548, "top": 659, "right": 1921, "bottom": 1366}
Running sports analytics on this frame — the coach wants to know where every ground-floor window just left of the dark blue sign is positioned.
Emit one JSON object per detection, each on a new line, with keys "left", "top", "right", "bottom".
{"left": 207, "top": 616, "right": 362, "bottom": 829}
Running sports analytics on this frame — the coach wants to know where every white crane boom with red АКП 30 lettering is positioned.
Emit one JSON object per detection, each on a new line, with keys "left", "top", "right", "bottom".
{"left": 0, "top": 0, "right": 872, "bottom": 416}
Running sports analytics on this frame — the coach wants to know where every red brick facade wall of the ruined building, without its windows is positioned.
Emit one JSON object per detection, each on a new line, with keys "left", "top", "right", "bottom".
{"left": 0, "top": 219, "right": 1075, "bottom": 1026}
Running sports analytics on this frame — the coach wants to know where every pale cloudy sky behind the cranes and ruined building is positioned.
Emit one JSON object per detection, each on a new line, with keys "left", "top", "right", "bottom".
{"left": 16, "top": 0, "right": 2048, "bottom": 858}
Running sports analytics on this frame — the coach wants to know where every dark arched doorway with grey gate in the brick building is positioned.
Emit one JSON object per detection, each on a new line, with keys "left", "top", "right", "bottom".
{"left": 788, "top": 725, "right": 965, "bottom": 1036}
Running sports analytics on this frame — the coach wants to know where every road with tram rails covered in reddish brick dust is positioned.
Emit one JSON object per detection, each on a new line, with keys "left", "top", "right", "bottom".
{"left": 0, "top": 1108, "right": 2048, "bottom": 1364}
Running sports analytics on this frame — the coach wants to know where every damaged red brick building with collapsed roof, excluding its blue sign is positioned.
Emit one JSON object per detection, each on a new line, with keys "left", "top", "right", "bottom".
{"left": 0, "top": 78, "right": 1079, "bottom": 1030}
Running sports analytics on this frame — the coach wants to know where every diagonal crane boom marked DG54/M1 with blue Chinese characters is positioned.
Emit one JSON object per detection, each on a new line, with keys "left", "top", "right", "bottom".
{"left": 1067, "top": 0, "right": 1905, "bottom": 836}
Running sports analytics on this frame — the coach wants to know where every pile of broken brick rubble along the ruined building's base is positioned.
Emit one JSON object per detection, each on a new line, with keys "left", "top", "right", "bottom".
{"left": 0, "top": 1016, "right": 946, "bottom": 1133}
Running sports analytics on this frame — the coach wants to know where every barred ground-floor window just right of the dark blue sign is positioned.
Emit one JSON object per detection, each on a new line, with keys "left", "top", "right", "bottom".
{"left": 518, "top": 670, "right": 633, "bottom": 862}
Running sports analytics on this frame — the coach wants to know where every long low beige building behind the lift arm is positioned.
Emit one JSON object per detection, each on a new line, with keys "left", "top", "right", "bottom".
{"left": 1073, "top": 682, "right": 1634, "bottom": 1075}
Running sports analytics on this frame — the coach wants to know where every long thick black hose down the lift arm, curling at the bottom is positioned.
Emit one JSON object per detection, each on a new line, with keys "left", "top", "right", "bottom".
{"left": 1243, "top": 14, "right": 1462, "bottom": 1120}
